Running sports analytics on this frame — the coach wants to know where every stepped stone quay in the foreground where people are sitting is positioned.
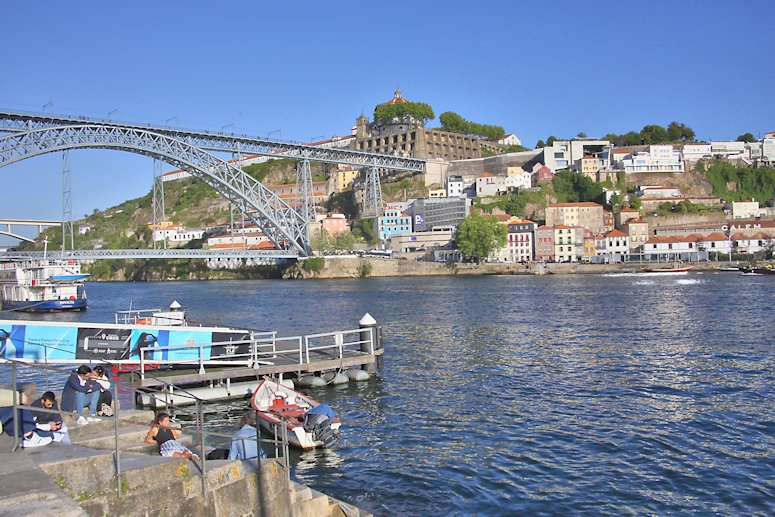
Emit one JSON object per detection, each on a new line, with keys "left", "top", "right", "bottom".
{"left": 0, "top": 410, "right": 370, "bottom": 517}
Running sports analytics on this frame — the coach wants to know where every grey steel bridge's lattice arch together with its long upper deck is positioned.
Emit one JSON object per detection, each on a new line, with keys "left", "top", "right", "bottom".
{"left": 0, "top": 111, "right": 425, "bottom": 256}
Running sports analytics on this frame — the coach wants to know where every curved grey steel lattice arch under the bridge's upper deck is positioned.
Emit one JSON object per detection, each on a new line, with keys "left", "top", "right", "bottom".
{"left": 0, "top": 122, "right": 311, "bottom": 256}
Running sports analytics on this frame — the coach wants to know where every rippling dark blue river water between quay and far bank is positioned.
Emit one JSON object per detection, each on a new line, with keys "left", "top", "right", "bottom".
{"left": 3, "top": 272, "right": 775, "bottom": 516}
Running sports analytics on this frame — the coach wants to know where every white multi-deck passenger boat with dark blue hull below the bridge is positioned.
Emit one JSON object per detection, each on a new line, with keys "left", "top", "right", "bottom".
{"left": 0, "top": 259, "right": 89, "bottom": 312}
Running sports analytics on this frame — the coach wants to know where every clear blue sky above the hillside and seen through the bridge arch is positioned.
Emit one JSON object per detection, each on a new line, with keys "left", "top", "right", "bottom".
{"left": 0, "top": 0, "right": 775, "bottom": 243}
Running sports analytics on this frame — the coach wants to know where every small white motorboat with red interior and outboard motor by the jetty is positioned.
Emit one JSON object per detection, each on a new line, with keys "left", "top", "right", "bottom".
{"left": 250, "top": 379, "right": 342, "bottom": 449}
